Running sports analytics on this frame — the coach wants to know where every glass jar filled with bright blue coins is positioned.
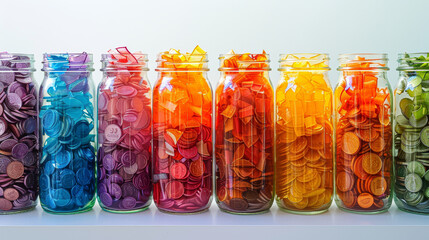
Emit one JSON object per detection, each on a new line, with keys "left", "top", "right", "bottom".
{"left": 39, "top": 52, "right": 95, "bottom": 214}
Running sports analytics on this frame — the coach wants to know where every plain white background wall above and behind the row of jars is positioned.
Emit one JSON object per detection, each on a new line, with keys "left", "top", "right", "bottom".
{"left": 0, "top": 0, "right": 429, "bottom": 87}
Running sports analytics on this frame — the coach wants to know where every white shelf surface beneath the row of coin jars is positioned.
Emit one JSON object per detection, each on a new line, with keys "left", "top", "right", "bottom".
{"left": 0, "top": 204, "right": 429, "bottom": 240}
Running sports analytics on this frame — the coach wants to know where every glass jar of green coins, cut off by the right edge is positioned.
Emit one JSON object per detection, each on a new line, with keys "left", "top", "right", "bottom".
{"left": 394, "top": 53, "right": 429, "bottom": 214}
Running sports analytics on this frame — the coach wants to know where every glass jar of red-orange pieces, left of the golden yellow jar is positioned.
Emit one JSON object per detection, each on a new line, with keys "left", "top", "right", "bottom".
{"left": 215, "top": 52, "right": 274, "bottom": 214}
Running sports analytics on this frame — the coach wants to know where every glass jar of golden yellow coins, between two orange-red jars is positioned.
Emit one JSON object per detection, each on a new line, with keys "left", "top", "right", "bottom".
{"left": 276, "top": 53, "right": 334, "bottom": 214}
